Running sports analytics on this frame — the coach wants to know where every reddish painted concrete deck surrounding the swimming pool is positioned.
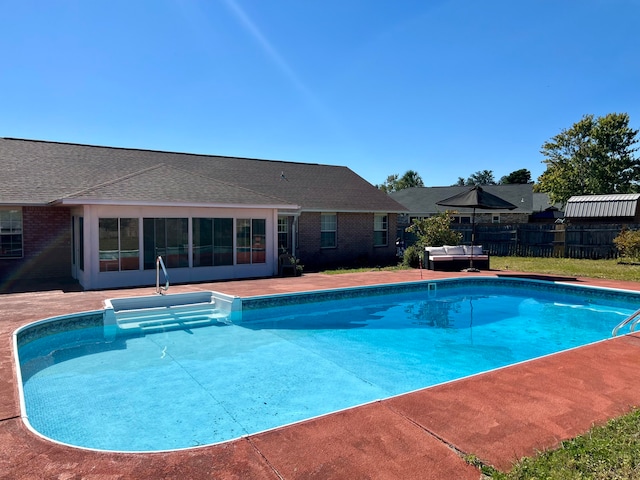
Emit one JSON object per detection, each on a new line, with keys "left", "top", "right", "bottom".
{"left": 0, "top": 270, "right": 640, "bottom": 480}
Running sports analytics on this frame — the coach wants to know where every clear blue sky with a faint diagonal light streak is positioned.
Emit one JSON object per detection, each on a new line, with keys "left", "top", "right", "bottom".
{"left": 0, "top": 0, "right": 640, "bottom": 186}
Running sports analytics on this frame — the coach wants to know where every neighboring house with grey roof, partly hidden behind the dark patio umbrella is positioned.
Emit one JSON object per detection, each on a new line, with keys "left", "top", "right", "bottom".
{"left": 389, "top": 184, "right": 533, "bottom": 227}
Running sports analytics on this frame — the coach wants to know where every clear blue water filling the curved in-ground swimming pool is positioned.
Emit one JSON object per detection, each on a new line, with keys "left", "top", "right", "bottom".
{"left": 19, "top": 279, "right": 640, "bottom": 451}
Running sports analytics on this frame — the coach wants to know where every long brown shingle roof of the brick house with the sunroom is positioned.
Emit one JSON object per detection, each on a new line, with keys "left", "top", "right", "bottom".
{"left": 0, "top": 138, "right": 404, "bottom": 212}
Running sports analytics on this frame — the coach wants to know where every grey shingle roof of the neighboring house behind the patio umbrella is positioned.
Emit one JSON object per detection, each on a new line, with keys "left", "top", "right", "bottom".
{"left": 390, "top": 184, "right": 533, "bottom": 215}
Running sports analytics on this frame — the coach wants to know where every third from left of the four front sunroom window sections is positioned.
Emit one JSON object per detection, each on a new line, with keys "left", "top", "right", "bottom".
{"left": 193, "top": 218, "right": 233, "bottom": 267}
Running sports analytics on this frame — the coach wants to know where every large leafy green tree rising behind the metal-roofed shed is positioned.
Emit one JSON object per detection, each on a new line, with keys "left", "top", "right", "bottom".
{"left": 535, "top": 113, "right": 640, "bottom": 204}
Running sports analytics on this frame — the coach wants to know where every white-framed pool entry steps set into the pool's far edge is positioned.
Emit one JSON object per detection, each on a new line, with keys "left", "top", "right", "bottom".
{"left": 104, "top": 291, "right": 242, "bottom": 339}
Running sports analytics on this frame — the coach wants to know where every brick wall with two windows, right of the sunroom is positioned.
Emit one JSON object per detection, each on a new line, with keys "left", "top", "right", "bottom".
{"left": 297, "top": 212, "right": 397, "bottom": 271}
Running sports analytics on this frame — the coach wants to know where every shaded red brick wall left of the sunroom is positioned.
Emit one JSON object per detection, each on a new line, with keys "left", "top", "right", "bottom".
{"left": 0, "top": 207, "right": 71, "bottom": 287}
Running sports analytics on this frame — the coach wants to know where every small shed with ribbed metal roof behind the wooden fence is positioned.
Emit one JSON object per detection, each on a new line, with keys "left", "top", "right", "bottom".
{"left": 564, "top": 193, "right": 640, "bottom": 224}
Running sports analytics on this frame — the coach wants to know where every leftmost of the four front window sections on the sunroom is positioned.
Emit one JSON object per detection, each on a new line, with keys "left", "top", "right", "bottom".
{"left": 98, "top": 218, "right": 140, "bottom": 272}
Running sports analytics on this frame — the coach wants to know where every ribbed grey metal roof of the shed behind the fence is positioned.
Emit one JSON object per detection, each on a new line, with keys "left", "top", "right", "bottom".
{"left": 564, "top": 193, "right": 640, "bottom": 218}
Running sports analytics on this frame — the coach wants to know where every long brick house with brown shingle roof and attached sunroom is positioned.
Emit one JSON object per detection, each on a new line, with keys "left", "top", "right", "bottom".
{"left": 0, "top": 138, "right": 405, "bottom": 289}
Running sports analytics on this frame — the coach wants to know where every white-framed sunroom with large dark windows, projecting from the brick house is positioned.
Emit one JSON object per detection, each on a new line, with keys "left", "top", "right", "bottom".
{"left": 62, "top": 200, "right": 298, "bottom": 289}
